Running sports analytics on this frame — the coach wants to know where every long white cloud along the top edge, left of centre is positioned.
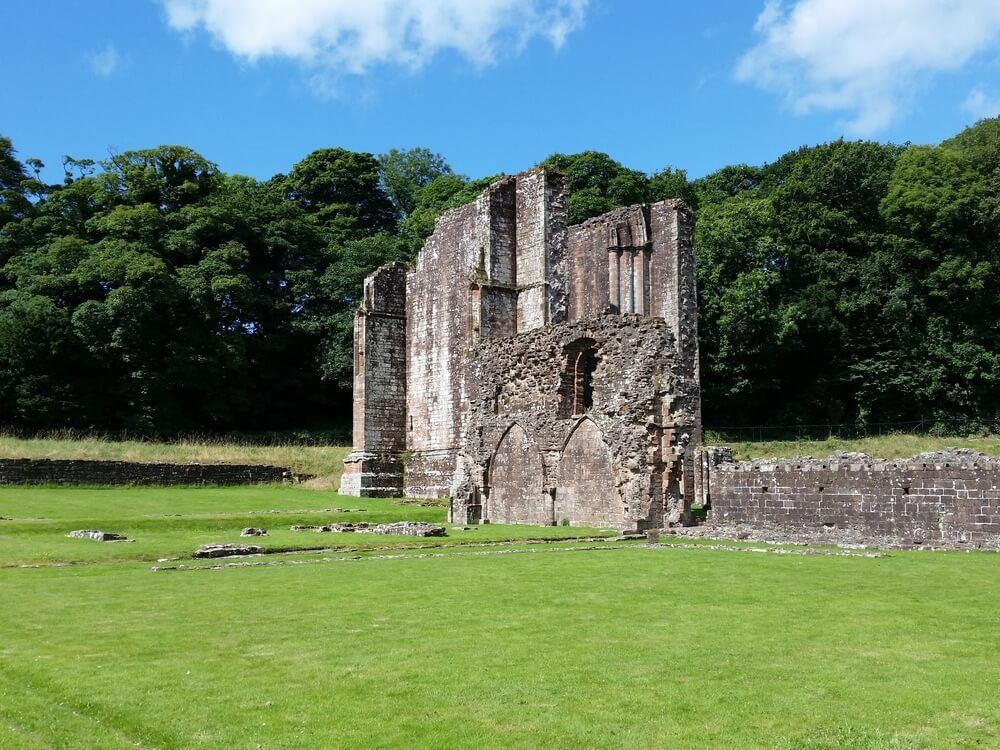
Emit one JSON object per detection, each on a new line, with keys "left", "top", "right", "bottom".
{"left": 162, "top": 0, "right": 589, "bottom": 74}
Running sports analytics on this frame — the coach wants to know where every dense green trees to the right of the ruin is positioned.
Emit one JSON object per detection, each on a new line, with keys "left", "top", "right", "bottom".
{"left": 694, "top": 126, "right": 1000, "bottom": 429}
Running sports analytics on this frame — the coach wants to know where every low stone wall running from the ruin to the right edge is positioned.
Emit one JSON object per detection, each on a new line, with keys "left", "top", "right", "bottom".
{"left": 699, "top": 449, "right": 1000, "bottom": 549}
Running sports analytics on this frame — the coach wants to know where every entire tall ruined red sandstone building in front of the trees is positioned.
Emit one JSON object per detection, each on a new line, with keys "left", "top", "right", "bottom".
{"left": 341, "top": 169, "right": 701, "bottom": 530}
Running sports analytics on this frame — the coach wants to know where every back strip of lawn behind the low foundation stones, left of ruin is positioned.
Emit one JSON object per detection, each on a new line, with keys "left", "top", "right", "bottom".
{"left": 0, "top": 485, "right": 612, "bottom": 568}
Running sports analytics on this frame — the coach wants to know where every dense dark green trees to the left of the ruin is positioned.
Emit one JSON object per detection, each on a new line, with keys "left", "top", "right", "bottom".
{"left": 0, "top": 146, "right": 406, "bottom": 434}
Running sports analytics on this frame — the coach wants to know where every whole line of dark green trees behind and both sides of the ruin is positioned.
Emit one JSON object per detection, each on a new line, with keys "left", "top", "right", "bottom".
{"left": 0, "top": 119, "right": 1000, "bottom": 435}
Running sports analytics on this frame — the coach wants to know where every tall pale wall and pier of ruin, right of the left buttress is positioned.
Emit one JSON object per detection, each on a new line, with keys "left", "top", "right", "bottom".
{"left": 405, "top": 170, "right": 566, "bottom": 497}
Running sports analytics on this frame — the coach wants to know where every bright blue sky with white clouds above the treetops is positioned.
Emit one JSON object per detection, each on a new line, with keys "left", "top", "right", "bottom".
{"left": 0, "top": 0, "right": 1000, "bottom": 185}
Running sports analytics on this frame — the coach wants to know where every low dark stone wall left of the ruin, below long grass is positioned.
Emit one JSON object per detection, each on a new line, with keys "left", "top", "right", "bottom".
{"left": 0, "top": 458, "right": 293, "bottom": 485}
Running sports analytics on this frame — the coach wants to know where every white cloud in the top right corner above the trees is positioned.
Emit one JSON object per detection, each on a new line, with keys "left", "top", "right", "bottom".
{"left": 736, "top": 0, "right": 1000, "bottom": 135}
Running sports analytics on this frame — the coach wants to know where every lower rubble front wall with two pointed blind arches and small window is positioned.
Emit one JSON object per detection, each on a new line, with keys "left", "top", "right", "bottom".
{"left": 452, "top": 315, "right": 697, "bottom": 529}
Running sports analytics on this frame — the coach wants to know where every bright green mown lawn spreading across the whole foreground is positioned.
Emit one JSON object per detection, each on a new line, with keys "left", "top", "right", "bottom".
{"left": 0, "top": 487, "right": 1000, "bottom": 750}
